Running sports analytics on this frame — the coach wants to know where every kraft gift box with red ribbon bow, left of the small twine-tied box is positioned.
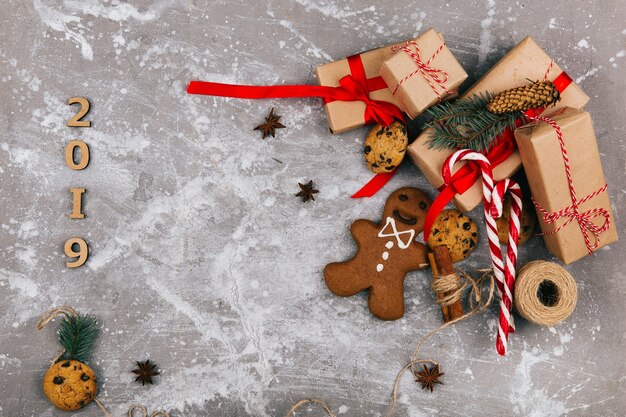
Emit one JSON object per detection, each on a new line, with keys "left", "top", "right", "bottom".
{"left": 315, "top": 34, "right": 443, "bottom": 133}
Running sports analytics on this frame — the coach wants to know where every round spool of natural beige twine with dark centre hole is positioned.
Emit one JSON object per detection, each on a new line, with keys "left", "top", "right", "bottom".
{"left": 515, "top": 261, "right": 578, "bottom": 326}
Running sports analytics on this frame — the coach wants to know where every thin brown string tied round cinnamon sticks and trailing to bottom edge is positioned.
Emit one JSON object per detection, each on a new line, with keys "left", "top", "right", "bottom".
{"left": 285, "top": 269, "right": 495, "bottom": 417}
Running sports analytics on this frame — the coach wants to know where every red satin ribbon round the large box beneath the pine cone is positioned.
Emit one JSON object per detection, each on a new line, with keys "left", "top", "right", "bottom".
{"left": 424, "top": 71, "right": 572, "bottom": 242}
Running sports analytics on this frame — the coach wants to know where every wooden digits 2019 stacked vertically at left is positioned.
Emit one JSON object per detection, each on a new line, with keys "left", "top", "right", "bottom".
{"left": 63, "top": 97, "right": 91, "bottom": 268}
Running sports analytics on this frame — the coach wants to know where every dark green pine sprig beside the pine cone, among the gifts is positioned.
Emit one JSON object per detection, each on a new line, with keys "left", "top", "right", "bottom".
{"left": 426, "top": 93, "right": 522, "bottom": 152}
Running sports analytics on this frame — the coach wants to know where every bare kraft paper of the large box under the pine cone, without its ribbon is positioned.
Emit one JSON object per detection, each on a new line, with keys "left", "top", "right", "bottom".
{"left": 407, "top": 37, "right": 589, "bottom": 212}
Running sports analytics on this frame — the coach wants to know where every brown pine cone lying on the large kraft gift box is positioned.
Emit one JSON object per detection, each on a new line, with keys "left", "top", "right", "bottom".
{"left": 487, "top": 81, "right": 561, "bottom": 114}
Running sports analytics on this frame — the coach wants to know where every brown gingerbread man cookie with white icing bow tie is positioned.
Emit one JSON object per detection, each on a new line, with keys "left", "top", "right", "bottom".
{"left": 324, "top": 187, "right": 431, "bottom": 320}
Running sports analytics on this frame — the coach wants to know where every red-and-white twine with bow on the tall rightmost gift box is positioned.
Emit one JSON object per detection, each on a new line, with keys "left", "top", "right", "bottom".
{"left": 529, "top": 116, "right": 611, "bottom": 255}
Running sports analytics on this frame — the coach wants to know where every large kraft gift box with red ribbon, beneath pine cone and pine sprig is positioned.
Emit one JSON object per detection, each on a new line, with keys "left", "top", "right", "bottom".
{"left": 407, "top": 37, "right": 589, "bottom": 211}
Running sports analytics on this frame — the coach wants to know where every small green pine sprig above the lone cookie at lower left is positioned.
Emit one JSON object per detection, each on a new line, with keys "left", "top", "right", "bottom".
{"left": 59, "top": 314, "right": 99, "bottom": 362}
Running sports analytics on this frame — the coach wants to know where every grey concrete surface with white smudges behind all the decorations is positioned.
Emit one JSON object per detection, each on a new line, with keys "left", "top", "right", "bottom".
{"left": 0, "top": 0, "right": 626, "bottom": 417}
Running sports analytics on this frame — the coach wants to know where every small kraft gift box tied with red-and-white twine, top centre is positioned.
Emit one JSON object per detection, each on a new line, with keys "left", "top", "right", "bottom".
{"left": 380, "top": 29, "right": 467, "bottom": 119}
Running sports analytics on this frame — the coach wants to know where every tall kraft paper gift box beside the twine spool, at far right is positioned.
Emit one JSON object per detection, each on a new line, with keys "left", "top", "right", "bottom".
{"left": 515, "top": 109, "right": 618, "bottom": 264}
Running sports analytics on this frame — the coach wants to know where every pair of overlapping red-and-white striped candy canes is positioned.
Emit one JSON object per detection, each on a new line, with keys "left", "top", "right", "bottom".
{"left": 442, "top": 149, "right": 522, "bottom": 355}
